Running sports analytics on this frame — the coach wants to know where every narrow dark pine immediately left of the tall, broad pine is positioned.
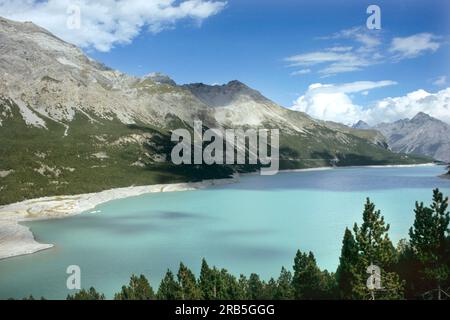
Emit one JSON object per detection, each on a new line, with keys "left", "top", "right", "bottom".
{"left": 336, "top": 228, "right": 358, "bottom": 300}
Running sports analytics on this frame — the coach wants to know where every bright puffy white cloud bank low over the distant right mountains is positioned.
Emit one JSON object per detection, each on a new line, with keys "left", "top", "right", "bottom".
{"left": 292, "top": 81, "right": 450, "bottom": 125}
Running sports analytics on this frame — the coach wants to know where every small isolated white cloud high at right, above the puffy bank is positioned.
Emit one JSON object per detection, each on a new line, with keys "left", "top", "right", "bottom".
{"left": 389, "top": 33, "right": 440, "bottom": 59}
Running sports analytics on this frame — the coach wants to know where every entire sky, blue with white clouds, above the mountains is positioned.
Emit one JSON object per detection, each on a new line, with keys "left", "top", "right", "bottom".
{"left": 0, "top": 0, "right": 450, "bottom": 123}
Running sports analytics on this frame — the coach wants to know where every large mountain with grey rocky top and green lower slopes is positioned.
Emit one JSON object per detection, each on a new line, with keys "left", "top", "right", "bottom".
{"left": 0, "top": 18, "right": 428, "bottom": 204}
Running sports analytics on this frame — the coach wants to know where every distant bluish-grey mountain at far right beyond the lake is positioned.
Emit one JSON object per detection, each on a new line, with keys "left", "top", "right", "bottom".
{"left": 353, "top": 112, "right": 450, "bottom": 163}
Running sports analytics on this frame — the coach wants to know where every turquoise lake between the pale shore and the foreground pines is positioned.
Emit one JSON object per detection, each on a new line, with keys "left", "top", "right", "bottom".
{"left": 0, "top": 166, "right": 450, "bottom": 299}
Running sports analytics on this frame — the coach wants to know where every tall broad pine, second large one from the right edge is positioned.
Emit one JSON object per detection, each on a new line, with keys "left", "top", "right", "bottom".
{"left": 352, "top": 199, "right": 404, "bottom": 299}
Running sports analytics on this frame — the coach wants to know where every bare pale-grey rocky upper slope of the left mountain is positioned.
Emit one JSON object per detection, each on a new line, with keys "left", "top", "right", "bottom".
{"left": 0, "top": 15, "right": 218, "bottom": 127}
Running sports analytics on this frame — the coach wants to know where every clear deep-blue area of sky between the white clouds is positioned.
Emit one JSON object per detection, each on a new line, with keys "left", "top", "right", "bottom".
{"left": 89, "top": 0, "right": 450, "bottom": 106}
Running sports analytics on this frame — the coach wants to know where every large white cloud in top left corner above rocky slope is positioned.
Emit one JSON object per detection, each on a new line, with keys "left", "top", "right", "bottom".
{"left": 0, "top": 0, "right": 226, "bottom": 51}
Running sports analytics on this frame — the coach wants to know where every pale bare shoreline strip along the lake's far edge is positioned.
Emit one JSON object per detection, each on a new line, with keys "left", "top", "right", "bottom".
{"left": 0, "top": 163, "right": 435, "bottom": 260}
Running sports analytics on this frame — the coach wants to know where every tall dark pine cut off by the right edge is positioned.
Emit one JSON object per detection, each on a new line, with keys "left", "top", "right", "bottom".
{"left": 409, "top": 189, "right": 450, "bottom": 300}
